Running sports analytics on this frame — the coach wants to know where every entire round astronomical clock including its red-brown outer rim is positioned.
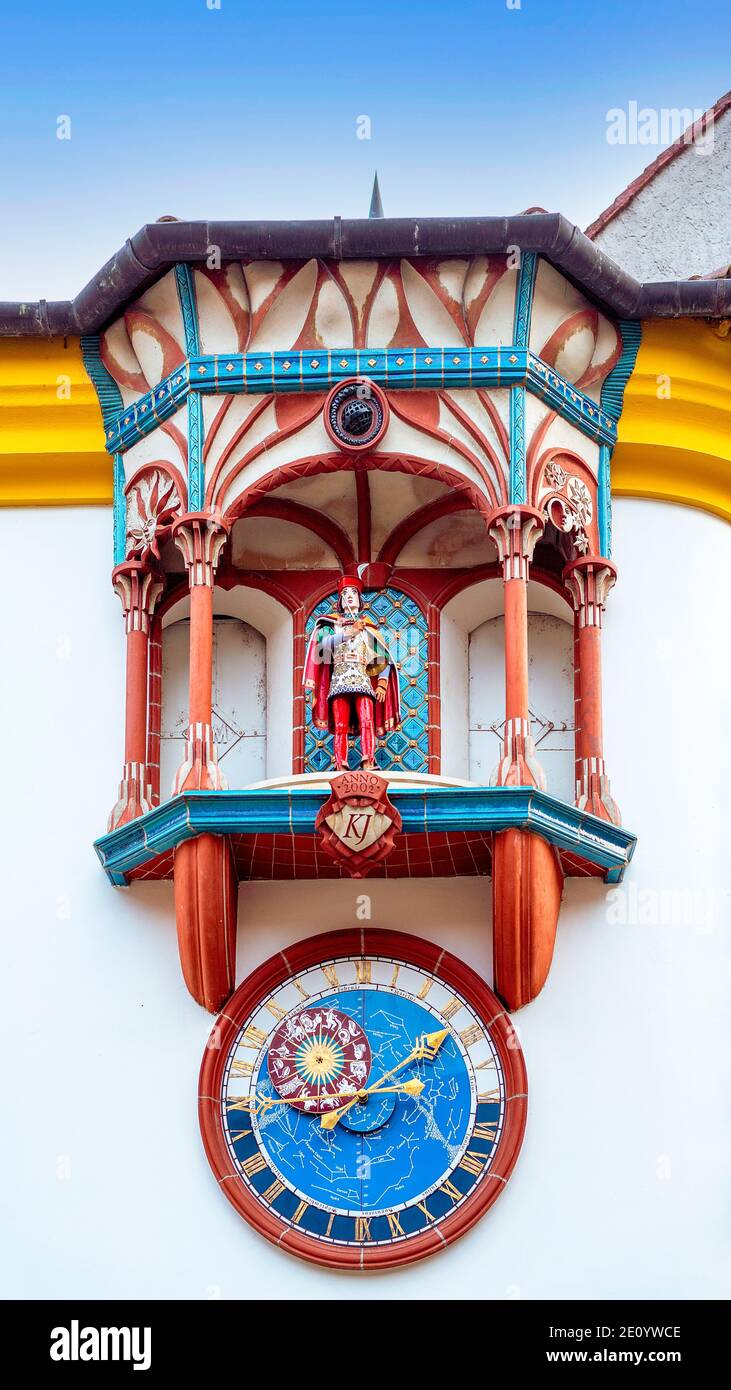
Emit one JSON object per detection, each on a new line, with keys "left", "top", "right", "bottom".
{"left": 199, "top": 930, "right": 527, "bottom": 1268}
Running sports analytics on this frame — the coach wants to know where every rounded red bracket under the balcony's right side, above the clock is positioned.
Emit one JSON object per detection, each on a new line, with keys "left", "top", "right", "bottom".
{"left": 492, "top": 830, "right": 563, "bottom": 1009}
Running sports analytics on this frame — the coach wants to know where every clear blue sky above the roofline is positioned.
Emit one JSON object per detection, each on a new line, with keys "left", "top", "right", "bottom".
{"left": 0, "top": 0, "right": 731, "bottom": 299}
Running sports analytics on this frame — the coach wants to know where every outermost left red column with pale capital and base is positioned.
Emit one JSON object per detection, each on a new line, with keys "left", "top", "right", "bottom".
{"left": 108, "top": 560, "right": 164, "bottom": 830}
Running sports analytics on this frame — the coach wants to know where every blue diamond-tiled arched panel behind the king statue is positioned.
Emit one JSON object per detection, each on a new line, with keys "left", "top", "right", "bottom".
{"left": 304, "top": 588, "right": 429, "bottom": 773}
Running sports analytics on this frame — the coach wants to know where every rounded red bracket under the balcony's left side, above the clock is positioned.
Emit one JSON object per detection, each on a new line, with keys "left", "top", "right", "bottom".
{"left": 172, "top": 835, "right": 239, "bottom": 1013}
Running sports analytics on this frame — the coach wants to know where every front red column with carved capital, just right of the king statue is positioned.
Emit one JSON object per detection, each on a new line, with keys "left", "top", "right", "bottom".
{"left": 488, "top": 507, "right": 546, "bottom": 791}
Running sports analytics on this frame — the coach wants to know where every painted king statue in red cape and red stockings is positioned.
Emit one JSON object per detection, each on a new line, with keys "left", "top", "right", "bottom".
{"left": 304, "top": 575, "right": 400, "bottom": 771}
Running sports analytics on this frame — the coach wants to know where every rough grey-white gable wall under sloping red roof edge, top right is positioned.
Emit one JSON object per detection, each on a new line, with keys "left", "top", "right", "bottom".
{"left": 595, "top": 111, "right": 731, "bottom": 279}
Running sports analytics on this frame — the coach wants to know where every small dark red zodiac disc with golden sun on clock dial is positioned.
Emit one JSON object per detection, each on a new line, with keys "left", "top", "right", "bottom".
{"left": 267, "top": 1008, "right": 371, "bottom": 1113}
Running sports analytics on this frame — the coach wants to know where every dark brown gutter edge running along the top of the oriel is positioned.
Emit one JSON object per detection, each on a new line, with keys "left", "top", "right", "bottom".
{"left": 0, "top": 213, "right": 731, "bottom": 338}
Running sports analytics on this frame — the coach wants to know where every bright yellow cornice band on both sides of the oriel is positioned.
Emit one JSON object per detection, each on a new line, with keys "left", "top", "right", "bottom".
{"left": 0, "top": 320, "right": 731, "bottom": 520}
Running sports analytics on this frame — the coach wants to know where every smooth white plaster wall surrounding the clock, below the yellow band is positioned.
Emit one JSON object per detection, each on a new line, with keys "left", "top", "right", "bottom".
{"left": 0, "top": 500, "right": 731, "bottom": 1302}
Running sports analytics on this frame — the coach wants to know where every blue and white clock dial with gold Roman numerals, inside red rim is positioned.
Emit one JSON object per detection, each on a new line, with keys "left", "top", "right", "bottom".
{"left": 221, "top": 955, "right": 507, "bottom": 1247}
